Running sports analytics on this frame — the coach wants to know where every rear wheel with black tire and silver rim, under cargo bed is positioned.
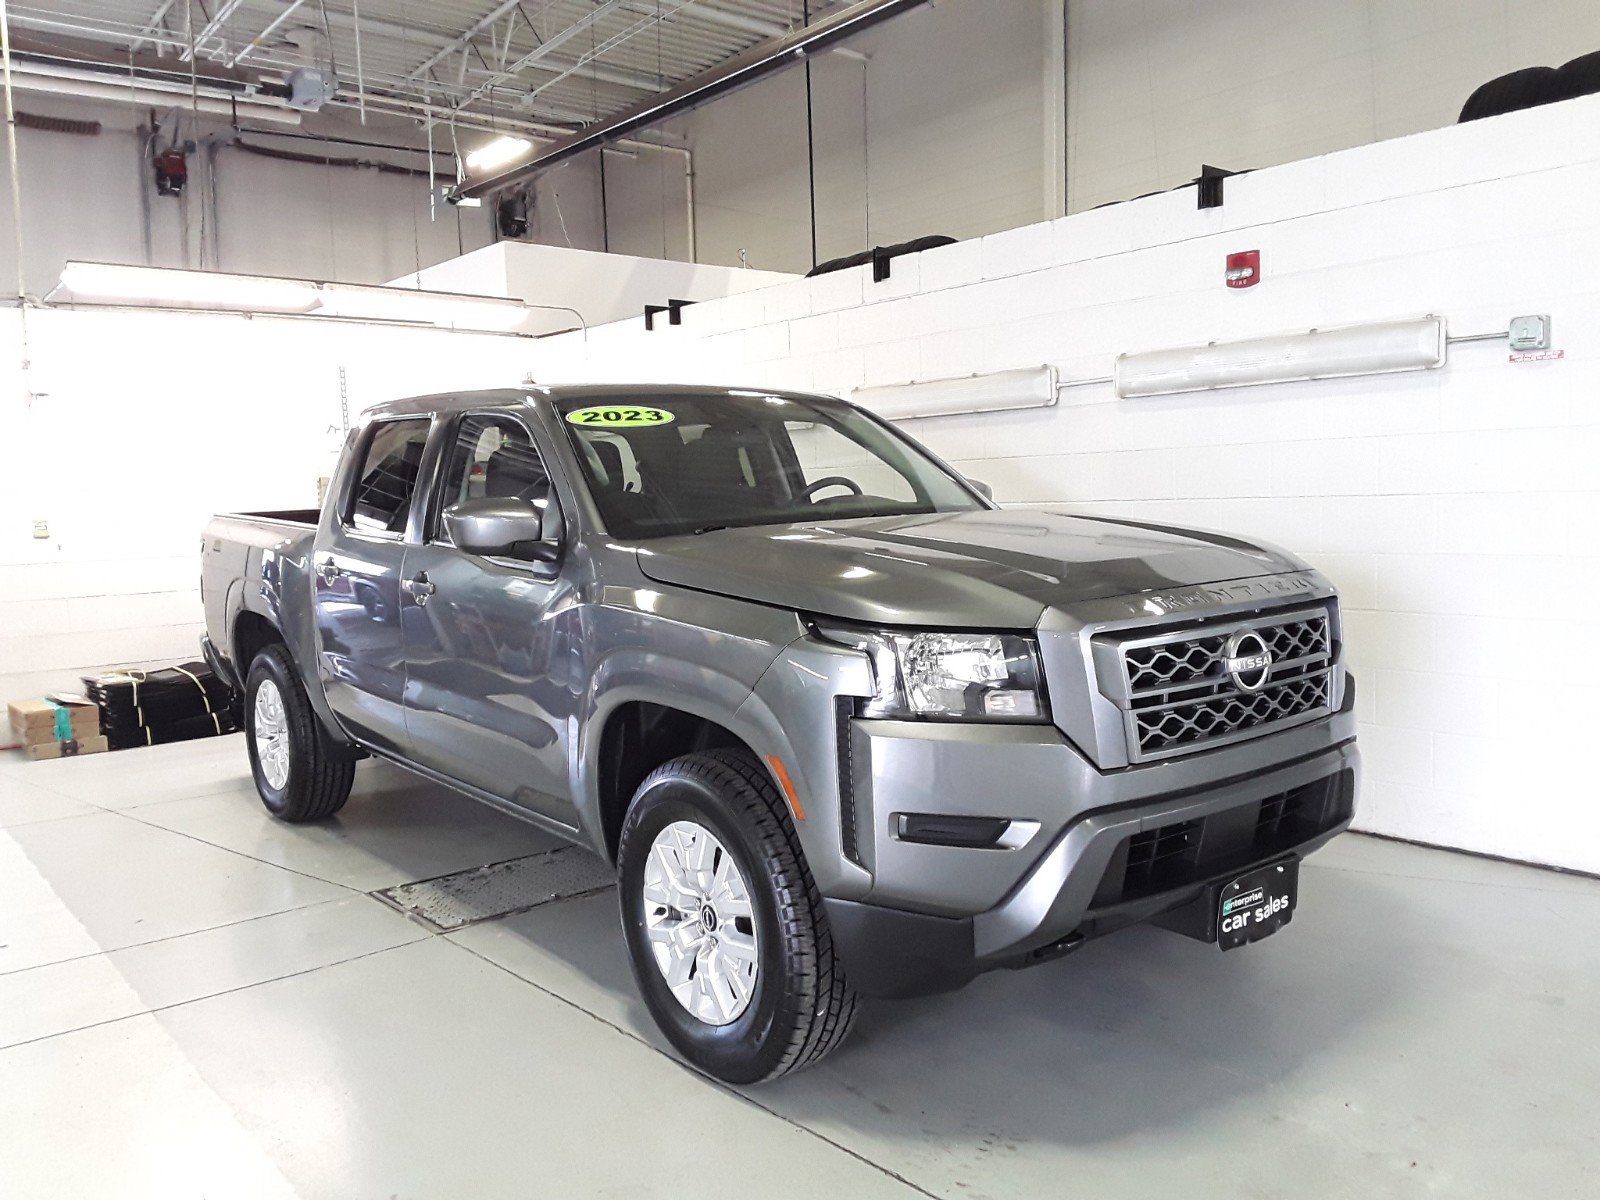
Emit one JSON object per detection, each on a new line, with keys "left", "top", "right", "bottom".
{"left": 245, "top": 645, "right": 355, "bottom": 824}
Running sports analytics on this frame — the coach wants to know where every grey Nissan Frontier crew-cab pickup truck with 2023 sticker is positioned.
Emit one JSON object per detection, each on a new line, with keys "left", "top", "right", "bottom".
{"left": 193, "top": 387, "right": 1358, "bottom": 1083}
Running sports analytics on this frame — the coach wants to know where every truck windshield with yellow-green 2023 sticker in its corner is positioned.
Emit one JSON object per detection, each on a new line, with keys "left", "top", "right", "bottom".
{"left": 557, "top": 392, "right": 982, "bottom": 538}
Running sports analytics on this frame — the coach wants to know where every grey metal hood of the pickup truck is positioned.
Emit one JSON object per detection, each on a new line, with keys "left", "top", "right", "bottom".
{"left": 638, "top": 509, "right": 1306, "bottom": 629}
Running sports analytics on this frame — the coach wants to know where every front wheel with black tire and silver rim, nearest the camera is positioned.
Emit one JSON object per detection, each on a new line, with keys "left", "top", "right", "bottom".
{"left": 618, "top": 750, "right": 856, "bottom": 1083}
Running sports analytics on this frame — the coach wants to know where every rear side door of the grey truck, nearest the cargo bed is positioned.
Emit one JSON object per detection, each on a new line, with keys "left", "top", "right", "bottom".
{"left": 312, "top": 416, "right": 432, "bottom": 750}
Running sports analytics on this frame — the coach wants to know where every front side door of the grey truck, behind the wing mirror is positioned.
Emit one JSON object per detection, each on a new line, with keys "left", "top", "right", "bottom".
{"left": 400, "top": 413, "right": 579, "bottom": 826}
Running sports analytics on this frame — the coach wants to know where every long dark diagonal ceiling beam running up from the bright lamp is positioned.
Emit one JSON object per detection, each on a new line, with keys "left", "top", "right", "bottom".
{"left": 453, "top": 0, "right": 928, "bottom": 200}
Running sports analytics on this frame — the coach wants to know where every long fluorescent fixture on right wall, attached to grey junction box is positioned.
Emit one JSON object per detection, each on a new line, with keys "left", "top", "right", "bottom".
{"left": 1112, "top": 317, "right": 1446, "bottom": 398}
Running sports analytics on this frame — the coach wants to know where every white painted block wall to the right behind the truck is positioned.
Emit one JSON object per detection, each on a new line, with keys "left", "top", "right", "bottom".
{"left": 538, "top": 98, "right": 1600, "bottom": 870}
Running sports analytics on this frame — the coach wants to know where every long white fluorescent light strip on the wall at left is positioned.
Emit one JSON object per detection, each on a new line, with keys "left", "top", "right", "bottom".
{"left": 59, "top": 262, "right": 528, "bottom": 333}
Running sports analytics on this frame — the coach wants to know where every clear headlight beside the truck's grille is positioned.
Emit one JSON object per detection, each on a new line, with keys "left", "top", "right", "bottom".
{"left": 818, "top": 626, "right": 1046, "bottom": 722}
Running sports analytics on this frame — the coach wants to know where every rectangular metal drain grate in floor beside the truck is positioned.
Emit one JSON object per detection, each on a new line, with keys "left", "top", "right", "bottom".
{"left": 371, "top": 846, "right": 616, "bottom": 933}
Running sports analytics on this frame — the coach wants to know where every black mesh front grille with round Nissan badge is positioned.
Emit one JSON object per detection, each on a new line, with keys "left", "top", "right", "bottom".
{"left": 1096, "top": 608, "right": 1334, "bottom": 762}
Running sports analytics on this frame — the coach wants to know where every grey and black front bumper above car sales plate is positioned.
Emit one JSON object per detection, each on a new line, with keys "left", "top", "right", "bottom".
{"left": 826, "top": 690, "right": 1360, "bottom": 995}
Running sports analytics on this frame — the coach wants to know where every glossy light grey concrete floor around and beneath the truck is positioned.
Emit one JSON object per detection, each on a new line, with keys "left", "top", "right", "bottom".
{"left": 0, "top": 736, "right": 1600, "bottom": 1200}
